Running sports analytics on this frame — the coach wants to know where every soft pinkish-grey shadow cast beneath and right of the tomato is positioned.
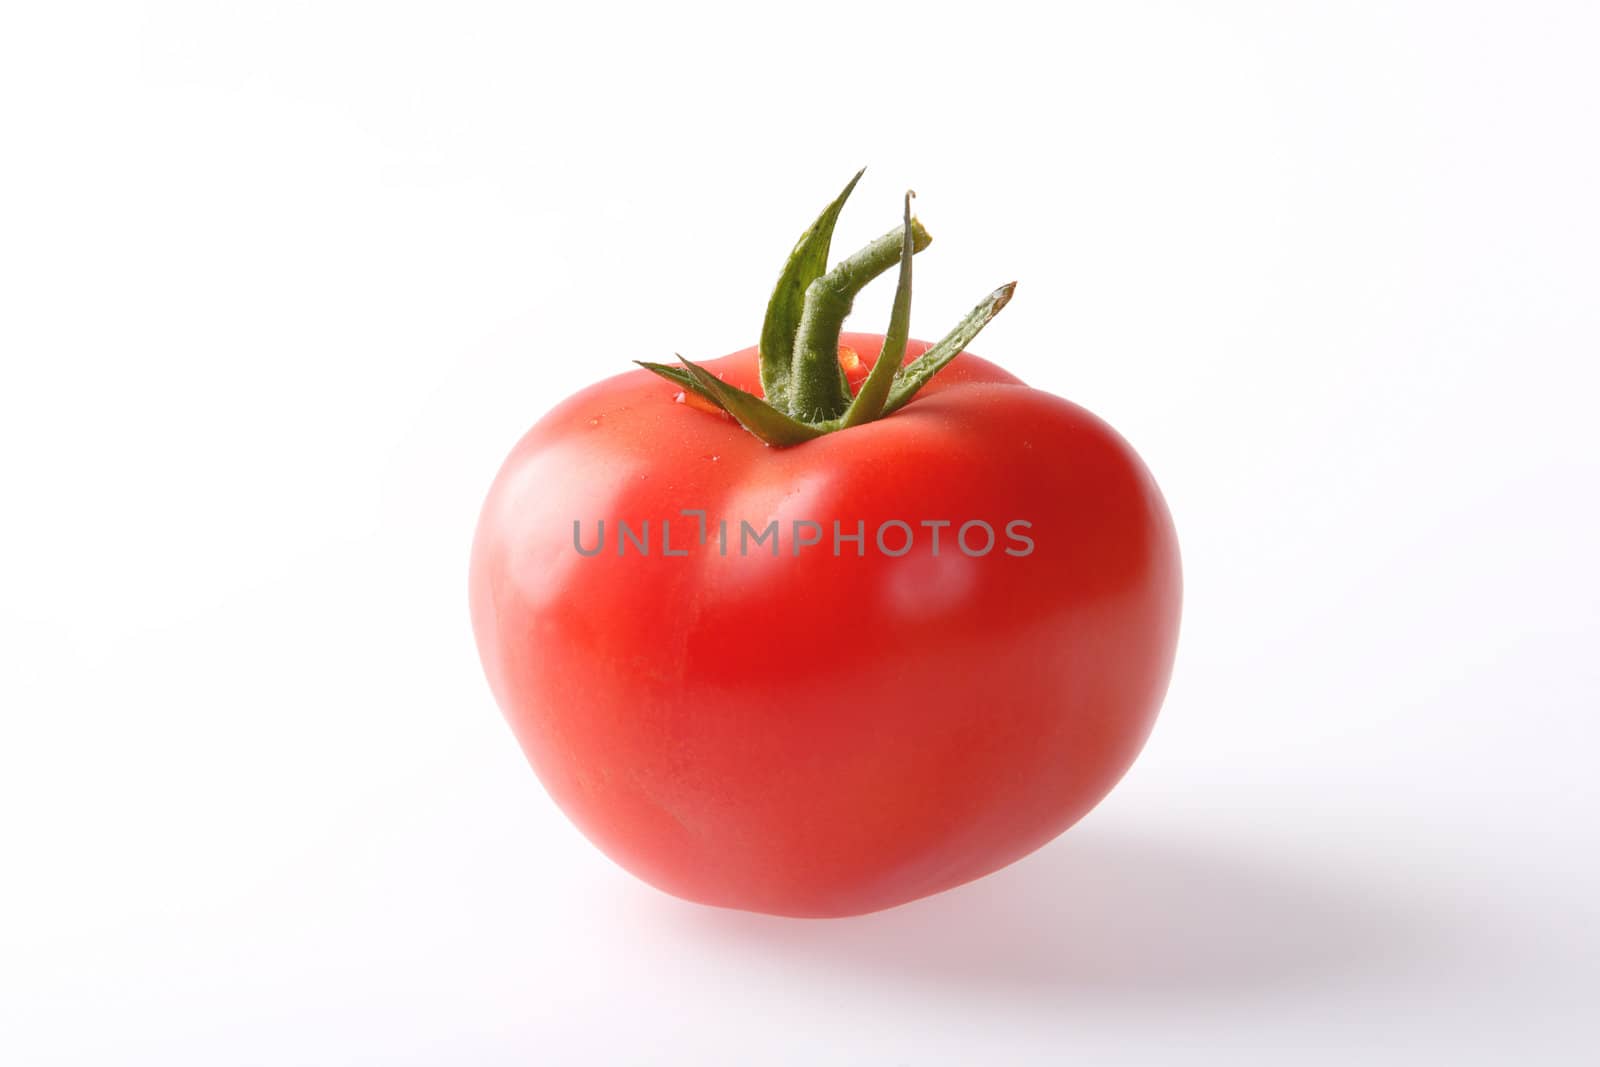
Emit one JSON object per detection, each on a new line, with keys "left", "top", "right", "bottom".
{"left": 664, "top": 830, "right": 1432, "bottom": 998}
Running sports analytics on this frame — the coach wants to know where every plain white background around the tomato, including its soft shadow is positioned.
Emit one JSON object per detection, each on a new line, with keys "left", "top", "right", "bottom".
{"left": 0, "top": 0, "right": 1600, "bottom": 1065}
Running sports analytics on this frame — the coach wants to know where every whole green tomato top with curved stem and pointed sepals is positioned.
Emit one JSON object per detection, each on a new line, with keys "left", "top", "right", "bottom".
{"left": 635, "top": 171, "right": 1016, "bottom": 448}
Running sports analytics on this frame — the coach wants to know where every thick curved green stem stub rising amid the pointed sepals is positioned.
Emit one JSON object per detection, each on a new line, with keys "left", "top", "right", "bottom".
{"left": 789, "top": 219, "right": 933, "bottom": 422}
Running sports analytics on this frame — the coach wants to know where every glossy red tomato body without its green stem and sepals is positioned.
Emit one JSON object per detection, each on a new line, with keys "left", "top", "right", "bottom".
{"left": 470, "top": 333, "right": 1181, "bottom": 917}
